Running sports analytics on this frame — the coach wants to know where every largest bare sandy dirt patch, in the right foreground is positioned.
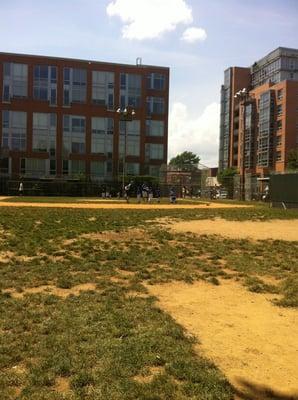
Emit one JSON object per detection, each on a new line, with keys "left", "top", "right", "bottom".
{"left": 147, "top": 281, "right": 298, "bottom": 399}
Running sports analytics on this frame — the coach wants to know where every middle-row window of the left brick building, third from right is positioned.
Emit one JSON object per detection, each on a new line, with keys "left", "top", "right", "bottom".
{"left": 91, "top": 117, "right": 114, "bottom": 157}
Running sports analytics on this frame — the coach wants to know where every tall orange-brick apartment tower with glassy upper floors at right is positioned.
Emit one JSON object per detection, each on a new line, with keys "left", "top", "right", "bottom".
{"left": 219, "top": 47, "right": 298, "bottom": 177}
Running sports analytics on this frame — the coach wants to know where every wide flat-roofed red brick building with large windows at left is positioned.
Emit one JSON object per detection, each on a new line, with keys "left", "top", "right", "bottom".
{"left": 0, "top": 53, "right": 169, "bottom": 181}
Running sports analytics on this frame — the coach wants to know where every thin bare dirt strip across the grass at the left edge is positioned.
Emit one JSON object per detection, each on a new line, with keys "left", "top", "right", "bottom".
{"left": 3, "top": 283, "right": 96, "bottom": 299}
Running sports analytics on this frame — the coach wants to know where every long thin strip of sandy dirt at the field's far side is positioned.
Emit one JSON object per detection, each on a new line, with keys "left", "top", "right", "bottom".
{"left": 0, "top": 198, "right": 251, "bottom": 210}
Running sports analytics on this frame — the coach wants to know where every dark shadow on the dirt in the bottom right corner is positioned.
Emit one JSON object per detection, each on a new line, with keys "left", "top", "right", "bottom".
{"left": 233, "top": 379, "right": 298, "bottom": 400}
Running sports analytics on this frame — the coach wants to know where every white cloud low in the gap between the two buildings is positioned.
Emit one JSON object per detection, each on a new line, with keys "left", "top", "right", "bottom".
{"left": 169, "top": 102, "right": 220, "bottom": 167}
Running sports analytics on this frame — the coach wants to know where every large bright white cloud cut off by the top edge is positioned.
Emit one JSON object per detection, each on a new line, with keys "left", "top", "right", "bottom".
{"left": 106, "top": 0, "right": 193, "bottom": 40}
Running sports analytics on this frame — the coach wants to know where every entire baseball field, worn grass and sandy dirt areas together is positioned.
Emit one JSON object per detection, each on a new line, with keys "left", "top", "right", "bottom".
{"left": 0, "top": 197, "right": 298, "bottom": 400}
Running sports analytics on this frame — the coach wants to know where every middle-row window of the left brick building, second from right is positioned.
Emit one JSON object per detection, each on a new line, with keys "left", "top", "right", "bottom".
{"left": 119, "top": 120, "right": 140, "bottom": 158}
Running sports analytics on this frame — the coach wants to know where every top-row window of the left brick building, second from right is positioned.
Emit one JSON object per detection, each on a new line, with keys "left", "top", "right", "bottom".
{"left": 120, "top": 74, "right": 142, "bottom": 108}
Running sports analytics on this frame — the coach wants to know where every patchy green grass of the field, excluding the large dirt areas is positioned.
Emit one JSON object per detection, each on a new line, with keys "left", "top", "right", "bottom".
{"left": 0, "top": 207, "right": 298, "bottom": 400}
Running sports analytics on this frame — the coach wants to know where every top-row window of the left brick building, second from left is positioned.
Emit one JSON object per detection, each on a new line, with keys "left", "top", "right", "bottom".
{"left": 33, "top": 65, "right": 57, "bottom": 105}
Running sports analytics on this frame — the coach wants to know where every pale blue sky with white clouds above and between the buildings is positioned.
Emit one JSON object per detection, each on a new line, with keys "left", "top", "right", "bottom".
{"left": 0, "top": 0, "right": 298, "bottom": 167}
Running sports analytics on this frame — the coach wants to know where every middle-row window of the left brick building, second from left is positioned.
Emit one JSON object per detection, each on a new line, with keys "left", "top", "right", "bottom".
{"left": 32, "top": 113, "right": 57, "bottom": 157}
